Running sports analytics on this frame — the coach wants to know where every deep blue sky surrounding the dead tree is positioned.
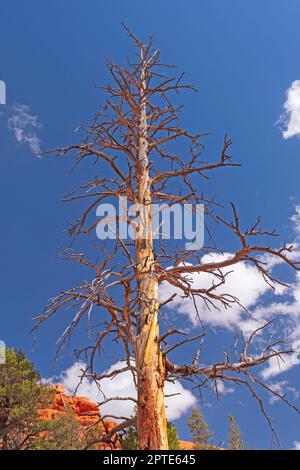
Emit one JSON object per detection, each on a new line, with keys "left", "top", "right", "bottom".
{"left": 0, "top": 0, "right": 300, "bottom": 448}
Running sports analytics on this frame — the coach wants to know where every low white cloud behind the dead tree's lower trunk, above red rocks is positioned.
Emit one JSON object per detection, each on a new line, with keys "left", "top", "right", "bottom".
{"left": 50, "top": 362, "right": 196, "bottom": 420}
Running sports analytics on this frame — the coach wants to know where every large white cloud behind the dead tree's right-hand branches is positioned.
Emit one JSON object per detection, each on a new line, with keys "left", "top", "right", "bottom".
{"left": 160, "top": 204, "right": 300, "bottom": 380}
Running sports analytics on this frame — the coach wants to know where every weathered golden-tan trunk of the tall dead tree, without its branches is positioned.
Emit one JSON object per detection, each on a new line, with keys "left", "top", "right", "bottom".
{"left": 135, "top": 53, "right": 168, "bottom": 450}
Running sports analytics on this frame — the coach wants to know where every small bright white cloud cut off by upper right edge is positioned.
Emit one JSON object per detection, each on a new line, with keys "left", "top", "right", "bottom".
{"left": 279, "top": 80, "right": 300, "bottom": 139}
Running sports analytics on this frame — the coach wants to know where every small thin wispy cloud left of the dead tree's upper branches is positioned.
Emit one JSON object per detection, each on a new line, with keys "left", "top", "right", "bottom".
{"left": 7, "top": 103, "right": 41, "bottom": 154}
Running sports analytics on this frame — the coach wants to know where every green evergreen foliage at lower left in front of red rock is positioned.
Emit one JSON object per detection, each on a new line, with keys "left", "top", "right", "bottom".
{"left": 0, "top": 349, "right": 105, "bottom": 450}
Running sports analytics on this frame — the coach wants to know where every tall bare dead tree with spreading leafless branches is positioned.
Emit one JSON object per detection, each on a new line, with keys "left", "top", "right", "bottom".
{"left": 37, "top": 28, "right": 299, "bottom": 450}
